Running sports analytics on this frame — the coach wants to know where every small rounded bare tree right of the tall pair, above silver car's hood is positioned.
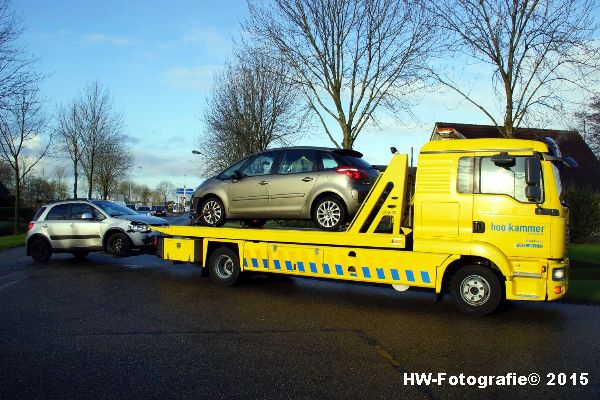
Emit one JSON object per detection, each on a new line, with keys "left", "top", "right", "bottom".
{"left": 94, "top": 135, "right": 133, "bottom": 200}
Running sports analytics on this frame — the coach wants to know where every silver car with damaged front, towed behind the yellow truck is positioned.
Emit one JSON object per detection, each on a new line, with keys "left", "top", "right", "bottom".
{"left": 25, "top": 200, "right": 169, "bottom": 262}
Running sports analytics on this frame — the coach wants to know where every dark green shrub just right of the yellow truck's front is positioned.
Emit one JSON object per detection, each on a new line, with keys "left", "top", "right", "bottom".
{"left": 563, "top": 186, "right": 600, "bottom": 243}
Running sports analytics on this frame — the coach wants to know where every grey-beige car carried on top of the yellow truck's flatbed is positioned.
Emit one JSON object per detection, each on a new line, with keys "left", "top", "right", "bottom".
{"left": 192, "top": 147, "right": 379, "bottom": 230}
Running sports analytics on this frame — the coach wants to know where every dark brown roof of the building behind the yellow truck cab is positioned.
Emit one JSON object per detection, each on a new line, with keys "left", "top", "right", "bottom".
{"left": 431, "top": 122, "right": 600, "bottom": 191}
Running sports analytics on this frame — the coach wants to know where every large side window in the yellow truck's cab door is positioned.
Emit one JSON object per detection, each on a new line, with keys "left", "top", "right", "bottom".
{"left": 479, "top": 157, "right": 540, "bottom": 203}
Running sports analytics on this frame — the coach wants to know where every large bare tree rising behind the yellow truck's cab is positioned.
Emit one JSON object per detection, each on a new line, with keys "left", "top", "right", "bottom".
{"left": 430, "top": 0, "right": 600, "bottom": 137}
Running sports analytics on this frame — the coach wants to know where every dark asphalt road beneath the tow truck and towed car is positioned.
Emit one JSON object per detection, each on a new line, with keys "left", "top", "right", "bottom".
{"left": 0, "top": 227, "right": 600, "bottom": 399}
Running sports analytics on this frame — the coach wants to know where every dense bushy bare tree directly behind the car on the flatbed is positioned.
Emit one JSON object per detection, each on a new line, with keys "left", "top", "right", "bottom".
{"left": 198, "top": 48, "right": 302, "bottom": 173}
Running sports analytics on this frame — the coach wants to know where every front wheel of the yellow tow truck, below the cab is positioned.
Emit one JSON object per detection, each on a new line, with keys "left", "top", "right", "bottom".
{"left": 450, "top": 265, "right": 503, "bottom": 315}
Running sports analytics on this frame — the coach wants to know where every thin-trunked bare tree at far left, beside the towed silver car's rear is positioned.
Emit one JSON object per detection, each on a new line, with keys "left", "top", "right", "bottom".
{"left": 0, "top": 87, "right": 52, "bottom": 234}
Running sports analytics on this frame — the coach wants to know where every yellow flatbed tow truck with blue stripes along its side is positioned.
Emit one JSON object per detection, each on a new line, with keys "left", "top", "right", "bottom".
{"left": 154, "top": 134, "right": 572, "bottom": 315}
